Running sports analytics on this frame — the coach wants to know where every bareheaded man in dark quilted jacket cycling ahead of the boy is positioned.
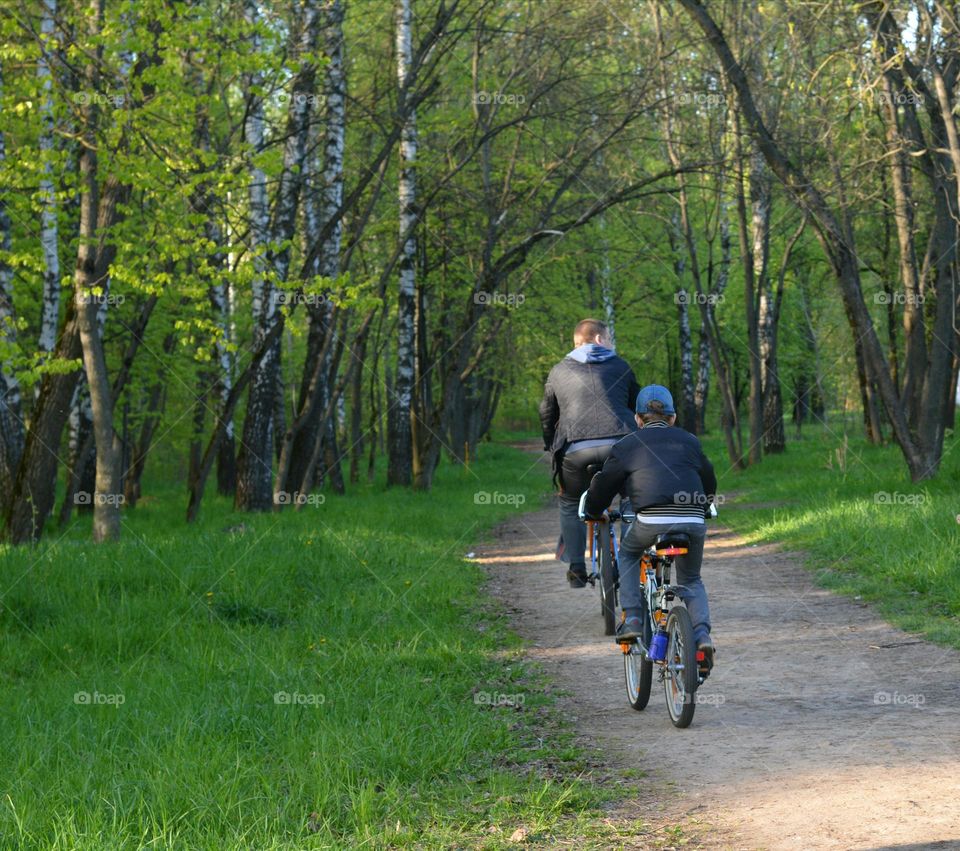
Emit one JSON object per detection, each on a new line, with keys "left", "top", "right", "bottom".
{"left": 540, "top": 319, "right": 640, "bottom": 588}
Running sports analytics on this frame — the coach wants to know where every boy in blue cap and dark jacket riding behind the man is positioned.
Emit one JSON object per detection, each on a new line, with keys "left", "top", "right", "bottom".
{"left": 584, "top": 384, "right": 717, "bottom": 671}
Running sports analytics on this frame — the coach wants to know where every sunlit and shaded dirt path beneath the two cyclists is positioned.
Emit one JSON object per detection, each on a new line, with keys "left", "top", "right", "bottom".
{"left": 476, "top": 502, "right": 960, "bottom": 851}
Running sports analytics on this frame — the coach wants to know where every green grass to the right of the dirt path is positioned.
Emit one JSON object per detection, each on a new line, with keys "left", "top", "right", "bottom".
{"left": 704, "top": 421, "right": 960, "bottom": 647}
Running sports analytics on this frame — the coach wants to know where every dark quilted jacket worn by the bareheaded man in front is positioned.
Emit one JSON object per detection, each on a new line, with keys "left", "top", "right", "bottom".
{"left": 540, "top": 346, "right": 640, "bottom": 455}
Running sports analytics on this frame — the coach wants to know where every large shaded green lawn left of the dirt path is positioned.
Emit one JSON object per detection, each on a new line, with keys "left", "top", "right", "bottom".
{"left": 0, "top": 445, "right": 622, "bottom": 851}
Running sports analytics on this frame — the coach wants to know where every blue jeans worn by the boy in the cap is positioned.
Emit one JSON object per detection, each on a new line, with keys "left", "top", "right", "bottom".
{"left": 620, "top": 520, "right": 710, "bottom": 642}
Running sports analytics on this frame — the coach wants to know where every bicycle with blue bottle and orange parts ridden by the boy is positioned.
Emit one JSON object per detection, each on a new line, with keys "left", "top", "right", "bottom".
{"left": 620, "top": 505, "right": 717, "bottom": 728}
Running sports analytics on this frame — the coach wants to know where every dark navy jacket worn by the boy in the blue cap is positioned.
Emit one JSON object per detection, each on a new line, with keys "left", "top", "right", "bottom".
{"left": 584, "top": 424, "right": 717, "bottom": 517}
